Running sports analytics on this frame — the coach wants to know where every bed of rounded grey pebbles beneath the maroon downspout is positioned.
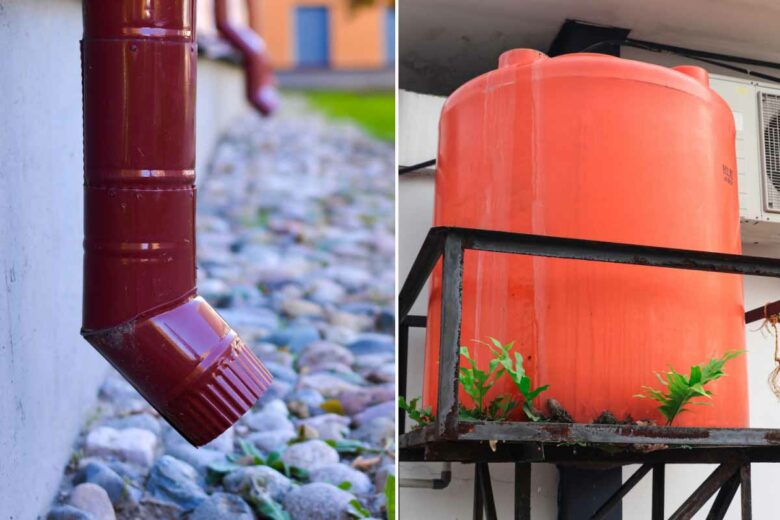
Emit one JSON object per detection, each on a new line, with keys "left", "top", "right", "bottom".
{"left": 48, "top": 99, "right": 395, "bottom": 520}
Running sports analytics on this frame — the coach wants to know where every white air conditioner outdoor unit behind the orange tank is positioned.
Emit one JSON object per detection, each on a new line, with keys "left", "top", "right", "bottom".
{"left": 710, "top": 75, "right": 780, "bottom": 244}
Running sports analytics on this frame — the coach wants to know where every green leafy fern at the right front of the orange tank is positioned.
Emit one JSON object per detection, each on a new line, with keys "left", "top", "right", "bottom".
{"left": 634, "top": 350, "right": 745, "bottom": 426}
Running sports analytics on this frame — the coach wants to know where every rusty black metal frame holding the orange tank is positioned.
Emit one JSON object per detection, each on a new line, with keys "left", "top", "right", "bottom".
{"left": 399, "top": 227, "right": 780, "bottom": 520}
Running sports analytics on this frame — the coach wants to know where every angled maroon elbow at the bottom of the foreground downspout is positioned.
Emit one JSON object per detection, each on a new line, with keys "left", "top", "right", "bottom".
{"left": 82, "top": 297, "right": 273, "bottom": 446}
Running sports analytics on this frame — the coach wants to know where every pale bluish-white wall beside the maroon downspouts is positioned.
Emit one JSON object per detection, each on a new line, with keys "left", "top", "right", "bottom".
{"left": 0, "top": 0, "right": 250, "bottom": 520}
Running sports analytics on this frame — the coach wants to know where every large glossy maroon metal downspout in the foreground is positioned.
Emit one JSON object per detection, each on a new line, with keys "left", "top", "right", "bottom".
{"left": 81, "top": 0, "right": 271, "bottom": 446}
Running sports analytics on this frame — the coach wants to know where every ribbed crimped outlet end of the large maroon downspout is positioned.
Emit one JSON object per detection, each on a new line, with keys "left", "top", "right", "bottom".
{"left": 164, "top": 336, "right": 272, "bottom": 446}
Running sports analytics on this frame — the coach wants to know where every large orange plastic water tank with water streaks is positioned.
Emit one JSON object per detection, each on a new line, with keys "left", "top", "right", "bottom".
{"left": 424, "top": 49, "right": 748, "bottom": 427}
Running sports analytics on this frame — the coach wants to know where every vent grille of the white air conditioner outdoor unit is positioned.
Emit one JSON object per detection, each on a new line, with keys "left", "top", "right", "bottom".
{"left": 761, "top": 92, "right": 780, "bottom": 213}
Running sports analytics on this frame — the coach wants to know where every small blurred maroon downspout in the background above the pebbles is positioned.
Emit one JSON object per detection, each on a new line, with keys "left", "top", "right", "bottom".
{"left": 214, "top": 0, "right": 279, "bottom": 116}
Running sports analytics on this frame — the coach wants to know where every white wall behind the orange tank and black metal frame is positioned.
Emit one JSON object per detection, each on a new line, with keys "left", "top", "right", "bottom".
{"left": 398, "top": 74, "right": 780, "bottom": 520}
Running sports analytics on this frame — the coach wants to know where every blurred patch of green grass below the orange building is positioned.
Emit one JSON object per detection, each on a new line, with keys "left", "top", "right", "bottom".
{"left": 304, "top": 91, "right": 395, "bottom": 141}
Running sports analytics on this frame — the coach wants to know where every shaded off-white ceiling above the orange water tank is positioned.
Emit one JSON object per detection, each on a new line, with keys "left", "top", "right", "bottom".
{"left": 397, "top": 0, "right": 780, "bottom": 94}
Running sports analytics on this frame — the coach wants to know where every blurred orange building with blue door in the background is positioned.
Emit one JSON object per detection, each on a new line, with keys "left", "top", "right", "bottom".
{"left": 249, "top": 0, "right": 395, "bottom": 70}
